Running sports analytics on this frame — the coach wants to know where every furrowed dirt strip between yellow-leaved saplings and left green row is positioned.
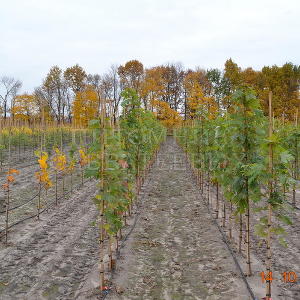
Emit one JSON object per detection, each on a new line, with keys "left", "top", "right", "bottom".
{"left": 0, "top": 183, "right": 98, "bottom": 300}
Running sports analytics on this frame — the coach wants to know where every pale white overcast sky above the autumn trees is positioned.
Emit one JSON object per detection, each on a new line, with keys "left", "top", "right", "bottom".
{"left": 0, "top": 0, "right": 300, "bottom": 92}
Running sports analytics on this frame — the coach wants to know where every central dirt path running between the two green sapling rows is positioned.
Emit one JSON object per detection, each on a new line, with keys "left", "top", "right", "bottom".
{"left": 107, "top": 138, "right": 250, "bottom": 300}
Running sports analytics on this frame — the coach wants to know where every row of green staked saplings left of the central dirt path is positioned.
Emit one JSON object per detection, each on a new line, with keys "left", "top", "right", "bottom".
{"left": 86, "top": 89, "right": 165, "bottom": 291}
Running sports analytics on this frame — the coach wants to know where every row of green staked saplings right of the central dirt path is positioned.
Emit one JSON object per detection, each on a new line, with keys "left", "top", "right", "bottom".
{"left": 176, "top": 88, "right": 300, "bottom": 299}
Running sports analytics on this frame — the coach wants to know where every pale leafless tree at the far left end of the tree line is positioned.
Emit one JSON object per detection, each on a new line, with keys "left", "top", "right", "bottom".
{"left": 0, "top": 76, "right": 22, "bottom": 120}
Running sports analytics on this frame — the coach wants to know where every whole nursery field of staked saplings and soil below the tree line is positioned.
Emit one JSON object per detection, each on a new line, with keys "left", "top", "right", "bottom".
{"left": 0, "top": 88, "right": 300, "bottom": 300}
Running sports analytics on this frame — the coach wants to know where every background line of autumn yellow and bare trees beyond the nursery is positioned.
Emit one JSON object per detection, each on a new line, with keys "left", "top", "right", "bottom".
{"left": 0, "top": 59, "right": 300, "bottom": 126}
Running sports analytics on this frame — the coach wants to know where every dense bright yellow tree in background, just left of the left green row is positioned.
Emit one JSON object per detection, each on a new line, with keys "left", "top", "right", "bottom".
{"left": 73, "top": 86, "right": 99, "bottom": 126}
